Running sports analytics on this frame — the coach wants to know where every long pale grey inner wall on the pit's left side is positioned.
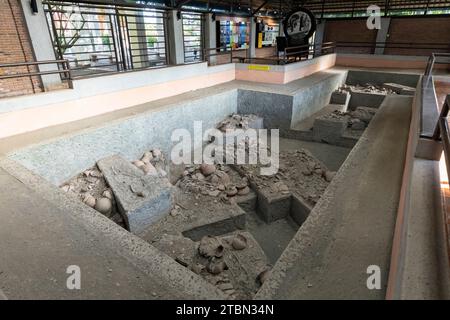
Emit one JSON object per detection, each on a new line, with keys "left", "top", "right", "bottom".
{"left": 9, "top": 90, "right": 237, "bottom": 185}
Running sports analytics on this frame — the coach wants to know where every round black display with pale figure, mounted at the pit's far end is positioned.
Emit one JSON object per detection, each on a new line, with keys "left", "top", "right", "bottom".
{"left": 283, "top": 8, "right": 316, "bottom": 46}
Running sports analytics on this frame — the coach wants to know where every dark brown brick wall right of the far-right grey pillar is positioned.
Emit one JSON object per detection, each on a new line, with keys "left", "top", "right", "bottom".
{"left": 385, "top": 17, "right": 450, "bottom": 56}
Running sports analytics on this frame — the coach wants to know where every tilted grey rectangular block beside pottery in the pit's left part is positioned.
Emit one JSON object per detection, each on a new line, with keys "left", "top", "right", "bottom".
{"left": 97, "top": 155, "right": 172, "bottom": 234}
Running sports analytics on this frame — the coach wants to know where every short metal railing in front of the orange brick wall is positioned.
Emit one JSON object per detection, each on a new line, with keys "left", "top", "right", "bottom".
{"left": 0, "top": 60, "right": 73, "bottom": 89}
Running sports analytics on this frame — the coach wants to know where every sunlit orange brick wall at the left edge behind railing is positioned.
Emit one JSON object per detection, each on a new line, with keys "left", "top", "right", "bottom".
{"left": 0, "top": 0, "right": 42, "bottom": 98}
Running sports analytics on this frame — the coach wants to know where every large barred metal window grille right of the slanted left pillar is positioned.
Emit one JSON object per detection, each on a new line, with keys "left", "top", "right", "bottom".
{"left": 43, "top": 0, "right": 168, "bottom": 78}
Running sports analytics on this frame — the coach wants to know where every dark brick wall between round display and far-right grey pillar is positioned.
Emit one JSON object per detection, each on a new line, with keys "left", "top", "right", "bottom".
{"left": 323, "top": 19, "right": 377, "bottom": 53}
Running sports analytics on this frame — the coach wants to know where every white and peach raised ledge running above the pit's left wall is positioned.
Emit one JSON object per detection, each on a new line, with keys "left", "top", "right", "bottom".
{"left": 0, "top": 64, "right": 235, "bottom": 138}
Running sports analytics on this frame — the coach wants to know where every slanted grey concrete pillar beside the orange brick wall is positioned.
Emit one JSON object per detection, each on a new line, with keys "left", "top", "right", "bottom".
{"left": 20, "top": 0, "right": 61, "bottom": 90}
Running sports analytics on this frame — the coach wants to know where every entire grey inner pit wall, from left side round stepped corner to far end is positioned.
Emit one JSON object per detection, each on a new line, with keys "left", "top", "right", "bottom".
{"left": 9, "top": 70, "right": 417, "bottom": 185}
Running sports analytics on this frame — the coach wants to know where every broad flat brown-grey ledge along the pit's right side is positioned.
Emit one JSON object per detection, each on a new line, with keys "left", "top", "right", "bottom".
{"left": 256, "top": 95, "right": 412, "bottom": 300}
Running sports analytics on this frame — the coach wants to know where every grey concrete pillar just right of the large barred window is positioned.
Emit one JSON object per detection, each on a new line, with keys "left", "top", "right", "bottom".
{"left": 166, "top": 10, "right": 184, "bottom": 65}
